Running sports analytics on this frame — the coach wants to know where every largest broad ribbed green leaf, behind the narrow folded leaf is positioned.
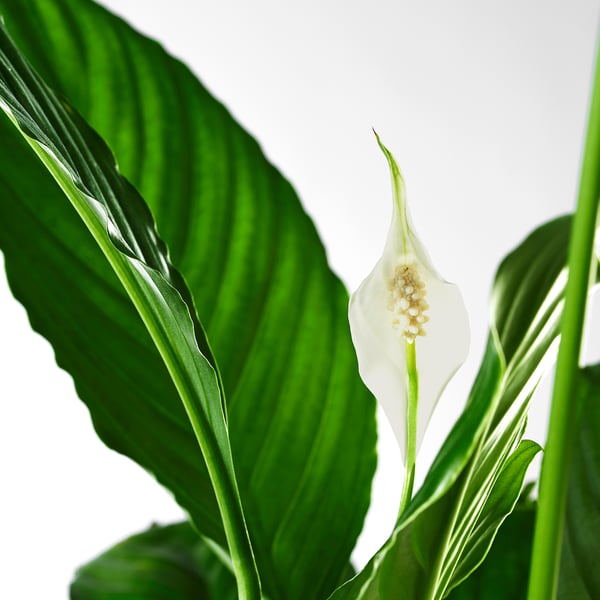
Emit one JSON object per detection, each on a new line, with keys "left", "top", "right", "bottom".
{"left": 0, "top": 0, "right": 375, "bottom": 599}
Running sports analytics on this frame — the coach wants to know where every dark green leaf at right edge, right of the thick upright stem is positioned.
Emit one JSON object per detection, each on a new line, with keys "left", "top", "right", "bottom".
{"left": 558, "top": 365, "right": 600, "bottom": 600}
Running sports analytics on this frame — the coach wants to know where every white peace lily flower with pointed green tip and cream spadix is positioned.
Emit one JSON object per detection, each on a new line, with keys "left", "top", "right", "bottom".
{"left": 349, "top": 134, "right": 469, "bottom": 462}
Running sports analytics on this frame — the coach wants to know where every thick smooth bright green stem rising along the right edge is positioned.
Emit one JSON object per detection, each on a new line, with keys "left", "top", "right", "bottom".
{"left": 528, "top": 38, "right": 600, "bottom": 600}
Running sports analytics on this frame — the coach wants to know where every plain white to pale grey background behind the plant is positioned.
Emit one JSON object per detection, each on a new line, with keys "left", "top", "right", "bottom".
{"left": 0, "top": 0, "right": 598, "bottom": 600}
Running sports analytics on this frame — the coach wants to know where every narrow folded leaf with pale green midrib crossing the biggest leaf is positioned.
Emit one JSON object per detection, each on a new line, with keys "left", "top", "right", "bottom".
{"left": 0, "top": 11, "right": 260, "bottom": 600}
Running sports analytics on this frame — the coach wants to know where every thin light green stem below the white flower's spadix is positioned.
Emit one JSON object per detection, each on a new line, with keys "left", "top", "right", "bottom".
{"left": 398, "top": 341, "right": 419, "bottom": 518}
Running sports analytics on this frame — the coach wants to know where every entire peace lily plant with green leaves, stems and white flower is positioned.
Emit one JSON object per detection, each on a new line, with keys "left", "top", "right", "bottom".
{"left": 0, "top": 0, "right": 600, "bottom": 600}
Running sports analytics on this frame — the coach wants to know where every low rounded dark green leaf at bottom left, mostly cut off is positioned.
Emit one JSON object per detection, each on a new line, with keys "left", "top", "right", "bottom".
{"left": 70, "top": 523, "right": 237, "bottom": 600}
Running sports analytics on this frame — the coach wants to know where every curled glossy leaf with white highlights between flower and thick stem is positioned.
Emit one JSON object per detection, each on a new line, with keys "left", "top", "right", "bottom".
{"left": 332, "top": 217, "right": 570, "bottom": 600}
